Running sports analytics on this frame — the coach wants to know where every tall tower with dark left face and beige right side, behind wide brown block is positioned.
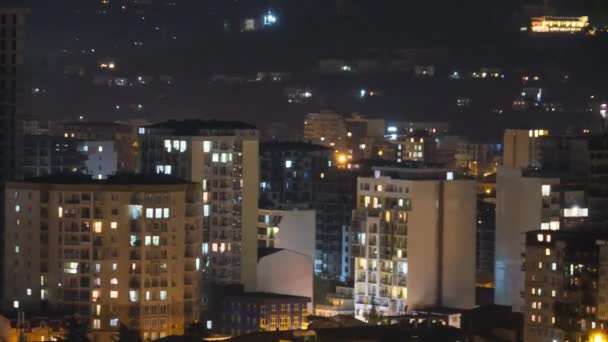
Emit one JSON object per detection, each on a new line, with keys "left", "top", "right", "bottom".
{"left": 139, "top": 120, "right": 260, "bottom": 291}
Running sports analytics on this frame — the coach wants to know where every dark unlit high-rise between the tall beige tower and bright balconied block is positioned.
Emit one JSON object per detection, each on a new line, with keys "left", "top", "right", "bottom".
{"left": 260, "top": 142, "right": 356, "bottom": 279}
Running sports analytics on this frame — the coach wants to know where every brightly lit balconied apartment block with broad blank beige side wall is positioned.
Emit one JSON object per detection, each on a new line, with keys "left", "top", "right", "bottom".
{"left": 351, "top": 168, "right": 477, "bottom": 319}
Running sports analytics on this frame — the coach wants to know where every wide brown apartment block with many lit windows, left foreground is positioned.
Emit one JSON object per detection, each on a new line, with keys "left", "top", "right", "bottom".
{"left": 2, "top": 175, "right": 202, "bottom": 341}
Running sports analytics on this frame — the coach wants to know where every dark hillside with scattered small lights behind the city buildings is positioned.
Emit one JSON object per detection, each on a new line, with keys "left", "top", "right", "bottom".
{"left": 5, "top": 0, "right": 608, "bottom": 141}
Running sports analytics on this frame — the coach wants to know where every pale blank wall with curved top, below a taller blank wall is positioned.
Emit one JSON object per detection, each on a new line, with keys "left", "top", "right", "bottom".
{"left": 257, "top": 249, "right": 314, "bottom": 312}
